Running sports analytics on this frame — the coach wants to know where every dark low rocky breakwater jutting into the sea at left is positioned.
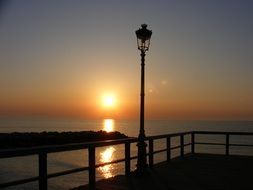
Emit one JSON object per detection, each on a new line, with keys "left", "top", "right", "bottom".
{"left": 0, "top": 131, "right": 128, "bottom": 149}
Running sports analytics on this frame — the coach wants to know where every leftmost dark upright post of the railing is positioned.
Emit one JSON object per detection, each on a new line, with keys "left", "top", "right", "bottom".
{"left": 39, "top": 153, "right": 47, "bottom": 190}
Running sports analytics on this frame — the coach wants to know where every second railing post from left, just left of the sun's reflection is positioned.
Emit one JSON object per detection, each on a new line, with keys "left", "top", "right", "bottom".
{"left": 89, "top": 146, "right": 96, "bottom": 190}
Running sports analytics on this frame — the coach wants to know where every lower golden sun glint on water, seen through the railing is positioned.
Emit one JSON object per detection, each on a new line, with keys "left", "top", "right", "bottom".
{"left": 98, "top": 146, "right": 115, "bottom": 178}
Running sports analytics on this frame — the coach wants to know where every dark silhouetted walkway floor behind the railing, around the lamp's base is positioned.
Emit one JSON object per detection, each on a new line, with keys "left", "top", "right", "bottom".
{"left": 70, "top": 154, "right": 253, "bottom": 190}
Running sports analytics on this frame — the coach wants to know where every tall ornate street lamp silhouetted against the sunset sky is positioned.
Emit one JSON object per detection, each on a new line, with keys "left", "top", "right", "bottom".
{"left": 135, "top": 24, "right": 152, "bottom": 174}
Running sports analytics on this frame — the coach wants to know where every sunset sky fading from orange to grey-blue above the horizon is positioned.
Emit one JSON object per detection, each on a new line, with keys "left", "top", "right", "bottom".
{"left": 0, "top": 0, "right": 253, "bottom": 120}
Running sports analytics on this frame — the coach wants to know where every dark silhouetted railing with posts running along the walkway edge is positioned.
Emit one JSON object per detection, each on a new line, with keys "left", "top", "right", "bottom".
{"left": 0, "top": 131, "right": 253, "bottom": 190}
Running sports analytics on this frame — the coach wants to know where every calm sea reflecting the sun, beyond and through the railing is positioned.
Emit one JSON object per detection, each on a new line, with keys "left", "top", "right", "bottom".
{"left": 0, "top": 117, "right": 253, "bottom": 190}
